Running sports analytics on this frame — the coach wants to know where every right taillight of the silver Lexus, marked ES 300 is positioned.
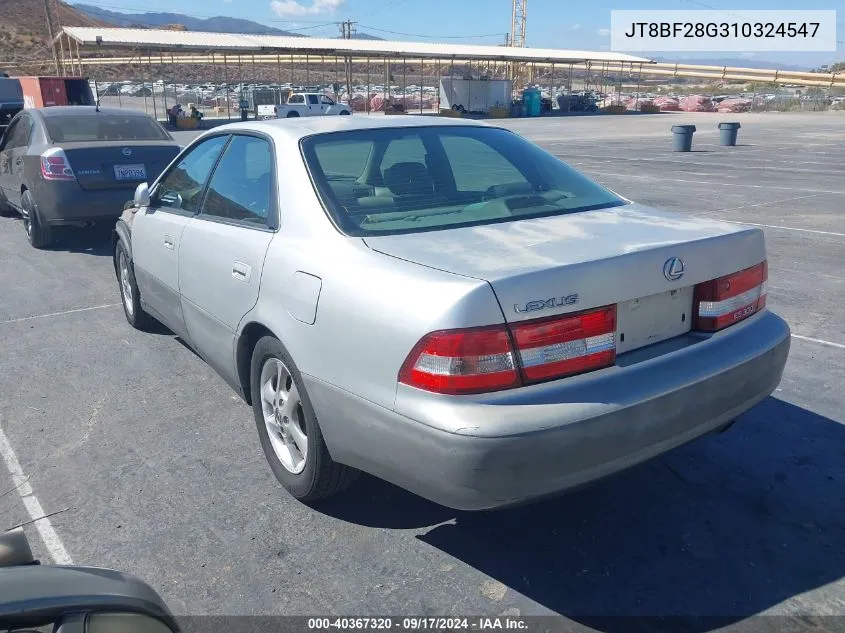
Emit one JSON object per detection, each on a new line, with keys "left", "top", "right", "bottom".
{"left": 692, "top": 261, "right": 769, "bottom": 332}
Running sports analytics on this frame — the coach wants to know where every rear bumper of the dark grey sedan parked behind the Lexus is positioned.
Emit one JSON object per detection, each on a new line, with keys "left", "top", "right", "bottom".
{"left": 32, "top": 182, "right": 134, "bottom": 225}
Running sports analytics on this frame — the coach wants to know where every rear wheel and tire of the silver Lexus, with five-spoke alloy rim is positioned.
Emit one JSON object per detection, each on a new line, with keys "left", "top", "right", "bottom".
{"left": 250, "top": 336, "right": 359, "bottom": 503}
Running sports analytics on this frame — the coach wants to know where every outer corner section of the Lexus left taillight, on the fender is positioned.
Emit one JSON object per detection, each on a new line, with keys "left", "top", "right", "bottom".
{"left": 399, "top": 326, "right": 520, "bottom": 394}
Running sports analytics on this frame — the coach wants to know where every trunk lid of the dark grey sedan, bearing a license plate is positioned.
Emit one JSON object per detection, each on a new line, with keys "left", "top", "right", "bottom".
{"left": 60, "top": 141, "right": 179, "bottom": 190}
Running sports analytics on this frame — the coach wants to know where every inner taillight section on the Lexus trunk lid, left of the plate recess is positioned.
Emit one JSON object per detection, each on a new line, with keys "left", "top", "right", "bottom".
{"left": 511, "top": 305, "right": 616, "bottom": 382}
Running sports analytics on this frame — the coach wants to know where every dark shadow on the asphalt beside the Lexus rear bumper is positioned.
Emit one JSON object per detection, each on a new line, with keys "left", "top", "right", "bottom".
{"left": 321, "top": 398, "right": 845, "bottom": 633}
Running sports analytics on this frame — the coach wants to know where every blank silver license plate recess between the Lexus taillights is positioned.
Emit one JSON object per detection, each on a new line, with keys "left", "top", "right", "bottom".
{"left": 616, "top": 286, "right": 694, "bottom": 354}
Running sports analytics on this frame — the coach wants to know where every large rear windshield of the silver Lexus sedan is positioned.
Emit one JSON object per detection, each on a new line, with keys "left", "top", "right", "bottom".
{"left": 302, "top": 126, "right": 625, "bottom": 237}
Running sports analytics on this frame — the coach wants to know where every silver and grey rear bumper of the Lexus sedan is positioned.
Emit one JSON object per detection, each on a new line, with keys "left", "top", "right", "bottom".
{"left": 305, "top": 312, "right": 790, "bottom": 510}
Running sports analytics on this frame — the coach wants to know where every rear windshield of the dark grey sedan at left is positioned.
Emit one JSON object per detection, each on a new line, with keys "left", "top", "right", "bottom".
{"left": 44, "top": 113, "right": 170, "bottom": 143}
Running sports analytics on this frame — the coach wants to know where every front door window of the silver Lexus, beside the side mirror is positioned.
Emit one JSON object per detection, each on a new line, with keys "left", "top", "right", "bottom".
{"left": 155, "top": 136, "right": 229, "bottom": 213}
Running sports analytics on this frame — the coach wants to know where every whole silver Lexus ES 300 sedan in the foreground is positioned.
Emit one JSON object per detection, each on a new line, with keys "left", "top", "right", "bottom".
{"left": 114, "top": 116, "right": 790, "bottom": 510}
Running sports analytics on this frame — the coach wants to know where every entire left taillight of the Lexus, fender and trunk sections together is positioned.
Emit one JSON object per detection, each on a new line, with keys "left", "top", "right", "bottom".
{"left": 399, "top": 305, "right": 616, "bottom": 394}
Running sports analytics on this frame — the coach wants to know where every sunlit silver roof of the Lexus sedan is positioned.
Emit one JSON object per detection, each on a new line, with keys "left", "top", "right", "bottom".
{"left": 208, "top": 114, "right": 486, "bottom": 139}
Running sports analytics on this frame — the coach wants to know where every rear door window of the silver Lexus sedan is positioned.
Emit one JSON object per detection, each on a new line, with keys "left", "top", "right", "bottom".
{"left": 200, "top": 136, "right": 273, "bottom": 226}
